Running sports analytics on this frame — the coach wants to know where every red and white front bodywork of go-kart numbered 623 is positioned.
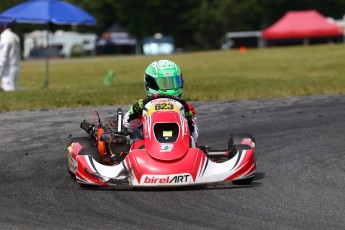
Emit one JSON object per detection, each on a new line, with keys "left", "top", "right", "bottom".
{"left": 68, "top": 98, "right": 256, "bottom": 187}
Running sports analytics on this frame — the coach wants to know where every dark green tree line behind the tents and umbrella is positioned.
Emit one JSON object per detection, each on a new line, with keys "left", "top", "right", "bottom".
{"left": 0, "top": 0, "right": 345, "bottom": 50}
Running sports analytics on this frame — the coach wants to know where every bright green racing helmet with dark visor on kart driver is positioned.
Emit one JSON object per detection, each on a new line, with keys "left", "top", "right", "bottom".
{"left": 144, "top": 60, "right": 183, "bottom": 97}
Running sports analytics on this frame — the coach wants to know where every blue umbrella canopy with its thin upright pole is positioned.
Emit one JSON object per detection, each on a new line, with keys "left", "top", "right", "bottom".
{"left": 0, "top": 0, "right": 96, "bottom": 88}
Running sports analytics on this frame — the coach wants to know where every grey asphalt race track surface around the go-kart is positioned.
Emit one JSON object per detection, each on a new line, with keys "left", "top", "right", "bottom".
{"left": 0, "top": 95, "right": 345, "bottom": 229}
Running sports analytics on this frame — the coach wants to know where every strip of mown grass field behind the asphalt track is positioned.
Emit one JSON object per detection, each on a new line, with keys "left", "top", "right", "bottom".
{"left": 0, "top": 44, "right": 345, "bottom": 111}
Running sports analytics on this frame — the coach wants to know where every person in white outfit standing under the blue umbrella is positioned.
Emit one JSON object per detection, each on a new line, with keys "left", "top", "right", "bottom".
{"left": 0, "top": 22, "right": 20, "bottom": 91}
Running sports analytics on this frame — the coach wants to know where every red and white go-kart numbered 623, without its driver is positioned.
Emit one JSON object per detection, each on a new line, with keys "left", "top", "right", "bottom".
{"left": 67, "top": 94, "right": 256, "bottom": 187}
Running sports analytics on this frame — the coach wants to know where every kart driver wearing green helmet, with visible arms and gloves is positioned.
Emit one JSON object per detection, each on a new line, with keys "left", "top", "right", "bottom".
{"left": 123, "top": 60, "right": 199, "bottom": 147}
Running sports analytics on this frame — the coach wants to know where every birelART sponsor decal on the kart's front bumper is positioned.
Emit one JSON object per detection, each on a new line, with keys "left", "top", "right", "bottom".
{"left": 141, "top": 173, "right": 192, "bottom": 185}
